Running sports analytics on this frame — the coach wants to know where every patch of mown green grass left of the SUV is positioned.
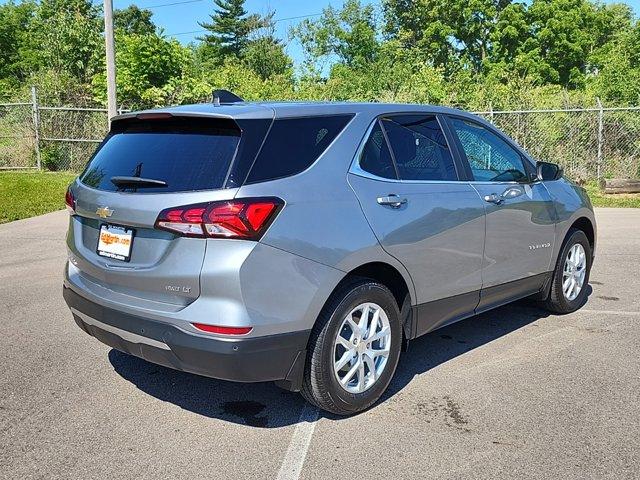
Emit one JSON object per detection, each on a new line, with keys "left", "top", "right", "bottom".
{"left": 0, "top": 172, "right": 76, "bottom": 223}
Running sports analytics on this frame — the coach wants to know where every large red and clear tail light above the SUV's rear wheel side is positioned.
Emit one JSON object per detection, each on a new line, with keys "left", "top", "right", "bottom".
{"left": 156, "top": 198, "right": 284, "bottom": 240}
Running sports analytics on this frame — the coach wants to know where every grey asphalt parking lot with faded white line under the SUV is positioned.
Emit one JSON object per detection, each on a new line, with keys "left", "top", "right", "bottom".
{"left": 0, "top": 209, "right": 640, "bottom": 479}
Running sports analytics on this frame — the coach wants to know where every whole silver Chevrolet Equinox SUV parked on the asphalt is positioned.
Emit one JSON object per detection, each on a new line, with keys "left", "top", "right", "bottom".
{"left": 64, "top": 96, "right": 596, "bottom": 414}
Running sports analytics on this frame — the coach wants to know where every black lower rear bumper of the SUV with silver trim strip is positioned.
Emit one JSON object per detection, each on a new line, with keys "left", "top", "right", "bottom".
{"left": 63, "top": 286, "right": 310, "bottom": 390}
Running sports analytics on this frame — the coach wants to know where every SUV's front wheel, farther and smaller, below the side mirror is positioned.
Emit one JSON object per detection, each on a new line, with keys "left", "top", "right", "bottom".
{"left": 544, "top": 228, "right": 592, "bottom": 313}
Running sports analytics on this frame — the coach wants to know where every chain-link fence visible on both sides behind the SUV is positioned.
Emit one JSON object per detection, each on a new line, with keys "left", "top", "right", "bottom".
{"left": 0, "top": 90, "right": 640, "bottom": 182}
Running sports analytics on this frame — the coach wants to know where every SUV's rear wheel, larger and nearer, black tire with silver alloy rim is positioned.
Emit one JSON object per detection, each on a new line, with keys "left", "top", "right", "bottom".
{"left": 301, "top": 278, "right": 402, "bottom": 415}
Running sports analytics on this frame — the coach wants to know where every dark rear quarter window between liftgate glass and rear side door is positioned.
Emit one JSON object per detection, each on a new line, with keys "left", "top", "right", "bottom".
{"left": 247, "top": 115, "right": 352, "bottom": 183}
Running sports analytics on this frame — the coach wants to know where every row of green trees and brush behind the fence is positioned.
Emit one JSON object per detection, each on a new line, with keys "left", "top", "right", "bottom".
{"left": 0, "top": 0, "right": 640, "bottom": 113}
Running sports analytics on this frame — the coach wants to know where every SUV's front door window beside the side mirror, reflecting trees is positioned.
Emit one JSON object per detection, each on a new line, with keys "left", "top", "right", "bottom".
{"left": 452, "top": 118, "right": 527, "bottom": 182}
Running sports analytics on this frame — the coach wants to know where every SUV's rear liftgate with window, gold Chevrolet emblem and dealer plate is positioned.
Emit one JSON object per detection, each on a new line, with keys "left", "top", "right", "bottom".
{"left": 67, "top": 113, "right": 270, "bottom": 309}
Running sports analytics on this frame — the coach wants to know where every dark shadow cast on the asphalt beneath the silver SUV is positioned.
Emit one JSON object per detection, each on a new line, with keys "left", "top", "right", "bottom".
{"left": 108, "top": 287, "right": 591, "bottom": 428}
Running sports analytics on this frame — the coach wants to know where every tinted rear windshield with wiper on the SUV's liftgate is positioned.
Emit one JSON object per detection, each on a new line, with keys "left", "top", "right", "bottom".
{"left": 80, "top": 119, "right": 240, "bottom": 193}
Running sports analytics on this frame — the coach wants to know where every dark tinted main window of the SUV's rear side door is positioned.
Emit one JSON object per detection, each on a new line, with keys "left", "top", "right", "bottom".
{"left": 383, "top": 115, "right": 458, "bottom": 180}
